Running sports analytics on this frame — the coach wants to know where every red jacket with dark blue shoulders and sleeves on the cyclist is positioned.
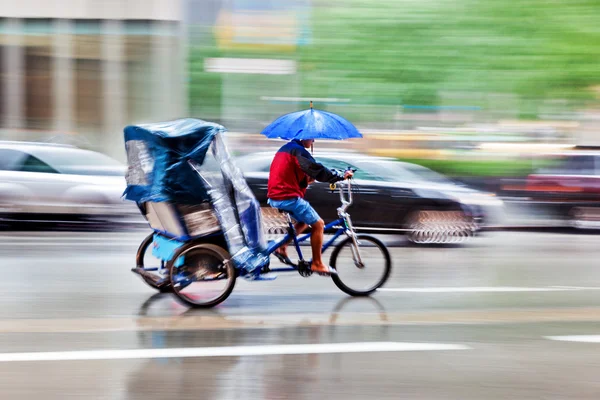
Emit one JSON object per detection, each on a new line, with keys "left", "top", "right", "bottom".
{"left": 267, "top": 140, "right": 344, "bottom": 200}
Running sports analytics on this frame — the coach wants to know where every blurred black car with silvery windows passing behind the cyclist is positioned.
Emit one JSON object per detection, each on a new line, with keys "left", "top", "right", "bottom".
{"left": 236, "top": 152, "right": 503, "bottom": 243}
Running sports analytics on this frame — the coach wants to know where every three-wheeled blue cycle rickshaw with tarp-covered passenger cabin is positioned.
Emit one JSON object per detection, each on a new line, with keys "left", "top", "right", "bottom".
{"left": 124, "top": 118, "right": 391, "bottom": 307}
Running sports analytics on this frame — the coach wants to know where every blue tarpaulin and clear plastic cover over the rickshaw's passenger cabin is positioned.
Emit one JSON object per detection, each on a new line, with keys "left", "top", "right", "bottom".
{"left": 125, "top": 118, "right": 269, "bottom": 272}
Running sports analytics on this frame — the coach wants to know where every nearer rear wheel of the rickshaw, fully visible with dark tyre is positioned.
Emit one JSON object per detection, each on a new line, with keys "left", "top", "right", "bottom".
{"left": 167, "top": 243, "right": 237, "bottom": 308}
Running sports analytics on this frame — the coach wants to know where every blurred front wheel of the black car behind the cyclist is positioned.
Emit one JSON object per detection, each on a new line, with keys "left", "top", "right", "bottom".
{"left": 405, "top": 209, "right": 477, "bottom": 245}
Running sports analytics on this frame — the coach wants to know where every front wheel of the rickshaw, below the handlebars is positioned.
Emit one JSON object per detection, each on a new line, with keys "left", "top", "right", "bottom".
{"left": 329, "top": 235, "right": 392, "bottom": 296}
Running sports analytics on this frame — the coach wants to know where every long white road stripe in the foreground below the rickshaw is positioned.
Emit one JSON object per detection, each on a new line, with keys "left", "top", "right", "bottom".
{"left": 0, "top": 342, "right": 471, "bottom": 362}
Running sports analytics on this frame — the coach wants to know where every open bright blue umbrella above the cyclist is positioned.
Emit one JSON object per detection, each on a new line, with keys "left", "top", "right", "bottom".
{"left": 262, "top": 101, "right": 362, "bottom": 140}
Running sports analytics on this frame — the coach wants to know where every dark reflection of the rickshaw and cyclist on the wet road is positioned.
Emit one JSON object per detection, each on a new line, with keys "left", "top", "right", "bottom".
{"left": 126, "top": 293, "right": 389, "bottom": 400}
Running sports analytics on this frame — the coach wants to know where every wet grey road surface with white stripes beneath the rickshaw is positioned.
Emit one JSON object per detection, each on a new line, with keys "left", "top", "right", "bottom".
{"left": 0, "top": 232, "right": 600, "bottom": 399}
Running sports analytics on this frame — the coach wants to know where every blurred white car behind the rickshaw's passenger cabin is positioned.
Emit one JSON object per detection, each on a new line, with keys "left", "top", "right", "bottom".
{"left": 0, "top": 141, "right": 139, "bottom": 220}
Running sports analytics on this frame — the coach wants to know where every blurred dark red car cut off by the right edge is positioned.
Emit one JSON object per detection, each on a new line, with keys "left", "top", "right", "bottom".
{"left": 524, "top": 150, "right": 600, "bottom": 229}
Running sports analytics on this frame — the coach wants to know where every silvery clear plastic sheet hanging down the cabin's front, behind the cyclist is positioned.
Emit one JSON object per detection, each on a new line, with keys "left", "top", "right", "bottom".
{"left": 192, "top": 134, "right": 269, "bottom": 272}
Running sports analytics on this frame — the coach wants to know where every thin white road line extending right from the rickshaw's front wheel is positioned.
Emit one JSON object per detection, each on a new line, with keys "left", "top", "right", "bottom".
{"left": 377, "top": 286, "right": 600, "bottom": 293}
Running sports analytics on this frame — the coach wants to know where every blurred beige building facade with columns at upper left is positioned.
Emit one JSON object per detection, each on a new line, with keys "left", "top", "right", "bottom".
{"left": 0, "top": 0, "right": 187, "bottom": 159}
